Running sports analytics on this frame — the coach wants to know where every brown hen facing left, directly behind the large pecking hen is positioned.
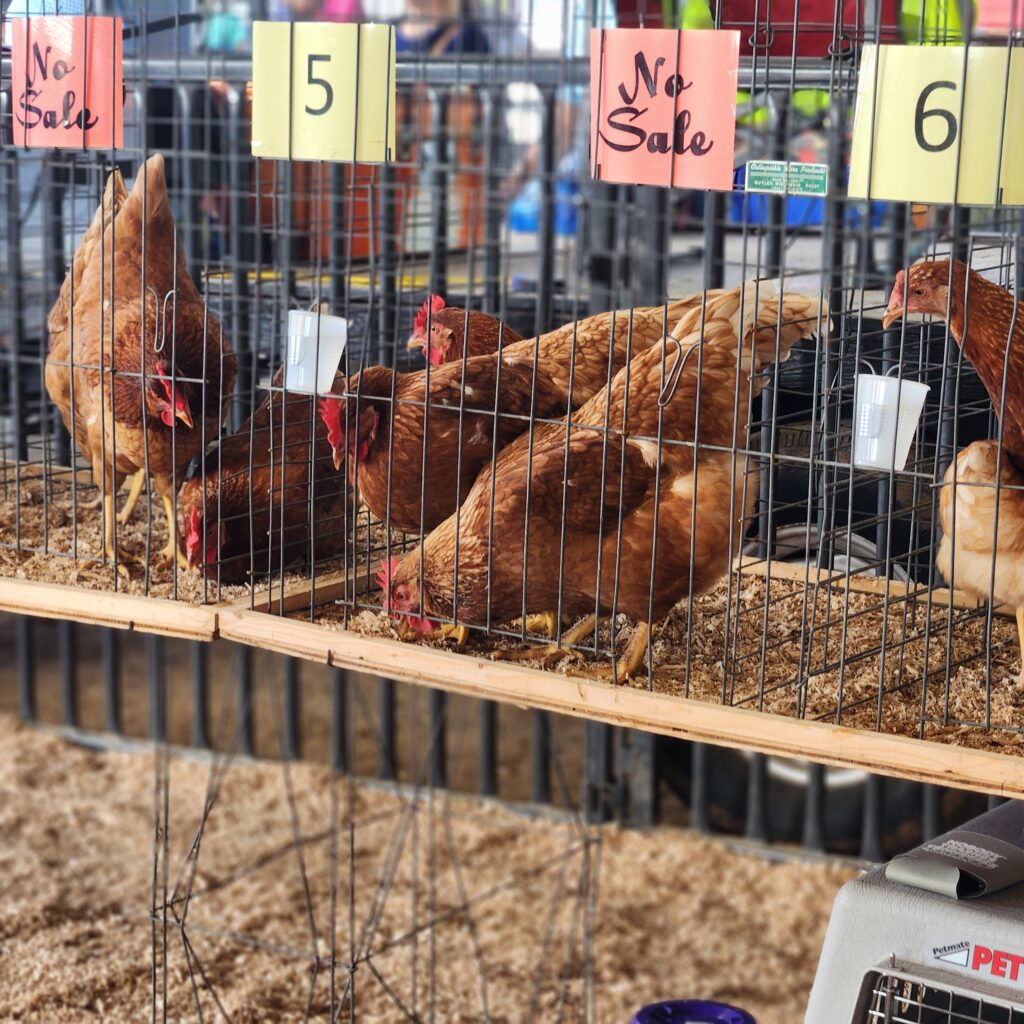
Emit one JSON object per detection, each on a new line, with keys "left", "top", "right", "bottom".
{"left": 321, "top": 296, "right": 720, "bottom": 534}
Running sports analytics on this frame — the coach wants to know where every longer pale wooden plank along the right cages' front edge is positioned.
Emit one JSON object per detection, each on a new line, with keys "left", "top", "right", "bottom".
{"left": 218, "top": 609, "right": 1024, "bottom": 797}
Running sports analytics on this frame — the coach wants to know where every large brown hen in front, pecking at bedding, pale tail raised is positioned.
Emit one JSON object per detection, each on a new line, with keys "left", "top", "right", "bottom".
{"left": 381, "top": 286, "right": 825, "bottom": 678}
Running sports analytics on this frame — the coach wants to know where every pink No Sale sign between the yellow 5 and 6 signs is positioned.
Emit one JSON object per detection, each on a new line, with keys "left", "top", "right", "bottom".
{"left": 590, "top": 29, "right": 739, "bottom": 189}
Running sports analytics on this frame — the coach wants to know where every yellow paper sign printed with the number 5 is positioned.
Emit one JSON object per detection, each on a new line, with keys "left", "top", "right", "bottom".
{"left": 252, "top": 22, "right": 395, "bottom": 163}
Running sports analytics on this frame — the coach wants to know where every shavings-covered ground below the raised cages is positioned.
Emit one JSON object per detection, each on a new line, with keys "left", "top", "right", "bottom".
{"left": 0, "top": 716, "right": 852, "bottom": 1024}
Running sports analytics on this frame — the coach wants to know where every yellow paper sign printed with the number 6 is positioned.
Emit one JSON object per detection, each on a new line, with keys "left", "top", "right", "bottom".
{"left": 849, "top": 46, "right": 1024, "bottom": 206}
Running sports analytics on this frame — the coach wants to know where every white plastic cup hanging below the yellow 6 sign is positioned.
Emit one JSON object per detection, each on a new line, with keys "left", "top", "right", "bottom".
{"left": 853, "top": 374, "right": 931, "bottom": 470}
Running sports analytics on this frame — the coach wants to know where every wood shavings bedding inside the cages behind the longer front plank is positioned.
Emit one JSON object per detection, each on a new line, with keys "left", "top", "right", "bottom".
{"left": 307, "top": 575, "right": 1024, "bottom": 757}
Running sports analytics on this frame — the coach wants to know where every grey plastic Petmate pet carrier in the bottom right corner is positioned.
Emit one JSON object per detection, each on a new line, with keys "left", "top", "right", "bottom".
{"left": 806, "top": 803, "right": 1024, "bottom": 1024}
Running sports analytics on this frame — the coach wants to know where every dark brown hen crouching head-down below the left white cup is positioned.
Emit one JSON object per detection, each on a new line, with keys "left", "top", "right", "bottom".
{"left": 178, "top": 368, "right": 344, "bottom": 583}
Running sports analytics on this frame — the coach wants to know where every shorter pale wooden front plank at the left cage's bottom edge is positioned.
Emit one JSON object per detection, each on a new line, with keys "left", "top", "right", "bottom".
{"left": 0, "top": 578, "right": 217, "bottom": 640}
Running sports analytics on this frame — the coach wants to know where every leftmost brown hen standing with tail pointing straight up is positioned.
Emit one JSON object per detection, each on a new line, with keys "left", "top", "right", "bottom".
{"left": 45, "top": 154, "right": 236, "bottom": 571}
